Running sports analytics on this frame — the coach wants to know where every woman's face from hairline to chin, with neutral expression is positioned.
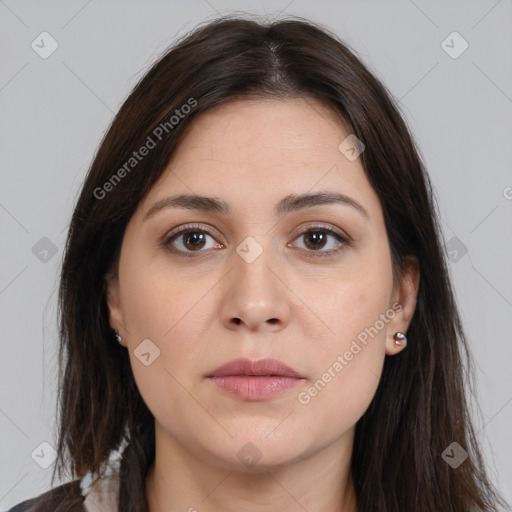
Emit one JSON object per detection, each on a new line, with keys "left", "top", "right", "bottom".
{"left": 108, "top": 99, "right": 418, "bottom": 469}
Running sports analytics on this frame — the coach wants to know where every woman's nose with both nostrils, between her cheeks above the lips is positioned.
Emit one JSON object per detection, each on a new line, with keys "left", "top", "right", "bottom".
{"left": 220, "top": 240, "right": 291, "bottom": 332}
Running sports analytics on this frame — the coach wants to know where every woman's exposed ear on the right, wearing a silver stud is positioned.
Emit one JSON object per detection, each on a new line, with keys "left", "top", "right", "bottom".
{"left": 386, "top": 256, "right": 420, "bottom": 356}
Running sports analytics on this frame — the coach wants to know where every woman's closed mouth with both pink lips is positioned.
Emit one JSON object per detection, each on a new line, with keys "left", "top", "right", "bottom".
{"left": 206, "top": 358, "right": 304, "bottom": 401}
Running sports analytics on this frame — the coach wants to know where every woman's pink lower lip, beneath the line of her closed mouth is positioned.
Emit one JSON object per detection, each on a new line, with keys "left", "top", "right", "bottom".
{"left": 210, "top": 375, "right": 302, "bottom": 401}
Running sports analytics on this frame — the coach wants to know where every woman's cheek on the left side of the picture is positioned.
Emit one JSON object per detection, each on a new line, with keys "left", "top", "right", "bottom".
{"left": 120, "top": 249, "right": 214, "bottom": 412}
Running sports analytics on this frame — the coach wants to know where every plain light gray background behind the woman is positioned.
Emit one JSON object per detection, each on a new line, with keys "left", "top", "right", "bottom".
{"left": 0, "top": 0, "right": 512, "bottom": 510}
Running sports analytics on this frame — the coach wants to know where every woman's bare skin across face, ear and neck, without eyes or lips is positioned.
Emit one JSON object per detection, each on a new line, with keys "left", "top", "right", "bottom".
{"left": 107, "top": 98, "right": 419, "bottom": 512}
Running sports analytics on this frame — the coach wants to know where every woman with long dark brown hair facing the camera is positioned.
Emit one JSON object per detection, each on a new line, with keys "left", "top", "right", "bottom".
{"left": 7, "top": 17, "right": 505, "bottom": 512}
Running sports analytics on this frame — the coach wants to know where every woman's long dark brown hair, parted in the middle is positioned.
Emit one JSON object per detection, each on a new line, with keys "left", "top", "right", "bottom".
{"left": 35, "top": 12, "right": 505, "bottom": 512}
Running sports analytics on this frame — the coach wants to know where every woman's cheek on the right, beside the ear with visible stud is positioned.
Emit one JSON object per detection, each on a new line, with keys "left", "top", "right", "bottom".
{"left": 297, "top": 248, "right": 394, "bottom": 420}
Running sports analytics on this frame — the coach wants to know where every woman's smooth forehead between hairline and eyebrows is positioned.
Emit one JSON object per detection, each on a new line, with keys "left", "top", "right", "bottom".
{"left": 137, "top": 98, "right": 378, "bottom": 220}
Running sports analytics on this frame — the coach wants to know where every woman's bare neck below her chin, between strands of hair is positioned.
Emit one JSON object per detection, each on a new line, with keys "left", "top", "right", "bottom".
{"left": 146, "top": 423, "right": 357, "bottom": 512}
